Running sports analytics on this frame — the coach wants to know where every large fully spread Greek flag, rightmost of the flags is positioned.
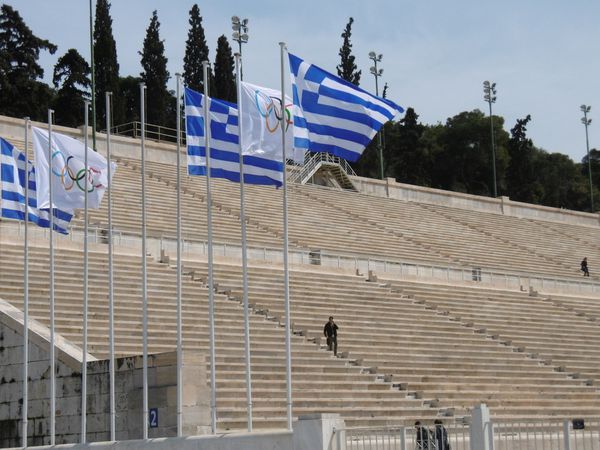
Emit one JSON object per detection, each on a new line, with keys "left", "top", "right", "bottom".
{"left": 289, "top": 53, "right": 404, "bottom": 162}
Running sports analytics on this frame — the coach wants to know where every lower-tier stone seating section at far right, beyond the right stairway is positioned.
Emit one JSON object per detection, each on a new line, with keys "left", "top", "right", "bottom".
{"left": 380, "top": 281, "right": 600, "bottom": 414}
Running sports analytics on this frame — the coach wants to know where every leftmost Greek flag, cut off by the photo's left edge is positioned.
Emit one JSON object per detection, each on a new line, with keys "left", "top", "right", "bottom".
{"left": 0, "top": 138, "right": 73, "bottom": 234}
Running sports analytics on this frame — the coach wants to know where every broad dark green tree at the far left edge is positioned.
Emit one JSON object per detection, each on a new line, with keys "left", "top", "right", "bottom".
{"left": 0, "top": 4, "right": 56, "bottom": 120}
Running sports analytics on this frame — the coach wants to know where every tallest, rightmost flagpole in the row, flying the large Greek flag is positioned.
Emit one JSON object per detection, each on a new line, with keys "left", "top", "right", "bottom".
{"left": 279, "top": 42, "right": 292, "bottom": 431}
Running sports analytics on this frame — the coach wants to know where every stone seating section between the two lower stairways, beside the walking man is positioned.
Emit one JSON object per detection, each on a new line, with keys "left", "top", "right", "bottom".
{"left": 176, "top": 260, "right": 597, "bottom": 416}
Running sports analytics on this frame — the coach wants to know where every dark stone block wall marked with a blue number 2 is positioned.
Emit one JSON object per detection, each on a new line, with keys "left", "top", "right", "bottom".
{"left": 0, "top": 300, "right": 210, "bottom": 447}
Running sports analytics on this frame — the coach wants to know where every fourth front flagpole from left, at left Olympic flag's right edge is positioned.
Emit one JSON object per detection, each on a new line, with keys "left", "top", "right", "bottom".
{"left": 105, "top": 92, "right": 117, "bottom": 441}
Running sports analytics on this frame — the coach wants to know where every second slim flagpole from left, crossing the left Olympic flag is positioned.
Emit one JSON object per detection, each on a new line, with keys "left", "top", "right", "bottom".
{"left": 48, "top": 109, "right": 56, "bottom": 445}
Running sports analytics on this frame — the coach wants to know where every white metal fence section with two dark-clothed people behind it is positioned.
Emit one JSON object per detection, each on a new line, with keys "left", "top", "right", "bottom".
{"left": 338, "top": 420, "right": 470, "bottom": 450}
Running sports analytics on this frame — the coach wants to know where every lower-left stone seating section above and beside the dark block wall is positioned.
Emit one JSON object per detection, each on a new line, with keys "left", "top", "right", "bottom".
{"left": 0, "top": 242, "right": 439, "bottom": 430}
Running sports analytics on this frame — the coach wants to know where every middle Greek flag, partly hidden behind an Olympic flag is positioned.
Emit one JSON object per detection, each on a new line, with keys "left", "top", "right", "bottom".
{"left": 185, "top": 88, "right": 284, "bottom": 186}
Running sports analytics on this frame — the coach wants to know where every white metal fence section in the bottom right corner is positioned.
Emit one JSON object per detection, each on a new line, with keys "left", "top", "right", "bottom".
{"left": 490, "top": 418, "right": 600, "bottom": 450}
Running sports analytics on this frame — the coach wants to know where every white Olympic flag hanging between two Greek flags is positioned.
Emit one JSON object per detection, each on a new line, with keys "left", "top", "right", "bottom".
{"left": 240, "top": 81, "right": 305, "bottom": 173}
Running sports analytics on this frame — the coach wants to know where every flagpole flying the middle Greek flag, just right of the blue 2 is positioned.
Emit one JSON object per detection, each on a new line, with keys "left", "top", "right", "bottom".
{"left": 175, "top": 73, "right": 183, "bottom": 437}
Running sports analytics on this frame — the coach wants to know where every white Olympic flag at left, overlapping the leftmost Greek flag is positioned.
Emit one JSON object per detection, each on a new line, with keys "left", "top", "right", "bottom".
{"left": 32, "top": 127, "right": 117, "bottom": 210}
